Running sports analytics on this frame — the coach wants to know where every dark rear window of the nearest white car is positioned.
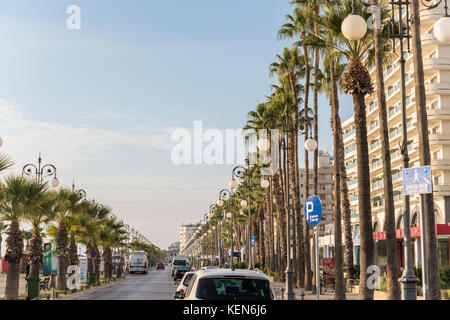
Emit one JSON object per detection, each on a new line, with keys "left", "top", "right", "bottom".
{"left": 196, "top": 278, "right": 273, "bottom": 300}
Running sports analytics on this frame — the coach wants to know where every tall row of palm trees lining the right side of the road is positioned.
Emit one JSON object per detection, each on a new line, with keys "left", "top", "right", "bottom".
{"left": 195, "top": 0, "right": 440, "bottom": 299}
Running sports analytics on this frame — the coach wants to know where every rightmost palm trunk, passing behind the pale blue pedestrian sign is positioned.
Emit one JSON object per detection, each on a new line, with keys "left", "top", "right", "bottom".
{"left": 412, "top": 0, "right": 441, "bottom": 300}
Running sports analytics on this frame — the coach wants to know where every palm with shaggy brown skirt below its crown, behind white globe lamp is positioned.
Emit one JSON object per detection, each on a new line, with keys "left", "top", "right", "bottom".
{"left": 316, "top": 0, "right": 374, "bottom": 300}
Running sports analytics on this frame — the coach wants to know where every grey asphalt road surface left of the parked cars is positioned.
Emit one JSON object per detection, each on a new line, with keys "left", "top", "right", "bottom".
{"left": 64, "top": 267, "right": 176, "bottom": 300}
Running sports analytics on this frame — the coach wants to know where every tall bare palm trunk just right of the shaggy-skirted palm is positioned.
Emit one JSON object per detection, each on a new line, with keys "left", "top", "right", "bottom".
{"left": 374, "top": 13, "right": 401, "bottom": 300}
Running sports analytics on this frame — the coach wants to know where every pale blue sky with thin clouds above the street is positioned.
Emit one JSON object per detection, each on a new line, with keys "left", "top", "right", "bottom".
{"left": 0, "top": 0, "right": 353, "bottom": 249}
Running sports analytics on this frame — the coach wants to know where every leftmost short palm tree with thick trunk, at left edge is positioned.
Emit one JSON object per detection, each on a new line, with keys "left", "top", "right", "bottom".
{"left": 0, "top": 176, "right": 27, "bottom": 300}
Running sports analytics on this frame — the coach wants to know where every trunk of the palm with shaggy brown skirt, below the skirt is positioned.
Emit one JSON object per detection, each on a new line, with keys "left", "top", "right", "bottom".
{"left": 353, "top": 93, "right": 374, "bottom": 300}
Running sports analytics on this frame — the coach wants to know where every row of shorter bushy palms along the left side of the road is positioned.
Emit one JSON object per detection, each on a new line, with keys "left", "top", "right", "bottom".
{"left": 0, "top": 155, "right": 162, "bottom": 300}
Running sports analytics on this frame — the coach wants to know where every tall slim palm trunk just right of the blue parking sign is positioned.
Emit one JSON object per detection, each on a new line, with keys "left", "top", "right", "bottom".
{"left": 330, "top": 58, "right": 346, "bottom": 300}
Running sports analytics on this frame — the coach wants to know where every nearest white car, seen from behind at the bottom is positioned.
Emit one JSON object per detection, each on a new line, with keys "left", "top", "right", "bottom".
{"left": 175, "top": 268, "right": 275, "bottom": 300}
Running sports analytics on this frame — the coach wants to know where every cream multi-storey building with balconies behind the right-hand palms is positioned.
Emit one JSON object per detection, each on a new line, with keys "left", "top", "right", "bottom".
{"left": 343, "top": 5, "right": 450, "bottom": 268}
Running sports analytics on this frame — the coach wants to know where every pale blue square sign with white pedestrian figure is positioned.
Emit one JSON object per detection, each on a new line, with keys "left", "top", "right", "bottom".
{"left": 403, "top": 166, "right": 433, "bottom": 195}
